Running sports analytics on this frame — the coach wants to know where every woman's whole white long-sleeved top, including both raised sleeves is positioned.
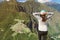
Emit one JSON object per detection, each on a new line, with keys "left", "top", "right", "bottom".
{"left": 33, "top": 12, "right": 53, "bottom": 31}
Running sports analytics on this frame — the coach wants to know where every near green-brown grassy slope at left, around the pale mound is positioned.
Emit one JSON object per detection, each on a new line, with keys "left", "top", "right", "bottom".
{"left": 0, "top": 2, "right": 37, "bottom": 40}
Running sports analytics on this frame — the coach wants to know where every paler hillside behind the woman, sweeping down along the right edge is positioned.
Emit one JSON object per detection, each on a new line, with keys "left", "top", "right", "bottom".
{"left": 16, "top": 1, "right": 60, "bottom": 37}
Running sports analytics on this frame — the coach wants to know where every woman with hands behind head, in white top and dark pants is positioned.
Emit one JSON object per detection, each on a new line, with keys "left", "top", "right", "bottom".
{"left": 33, "top": 11, "right": 53, "bottom": 40}
